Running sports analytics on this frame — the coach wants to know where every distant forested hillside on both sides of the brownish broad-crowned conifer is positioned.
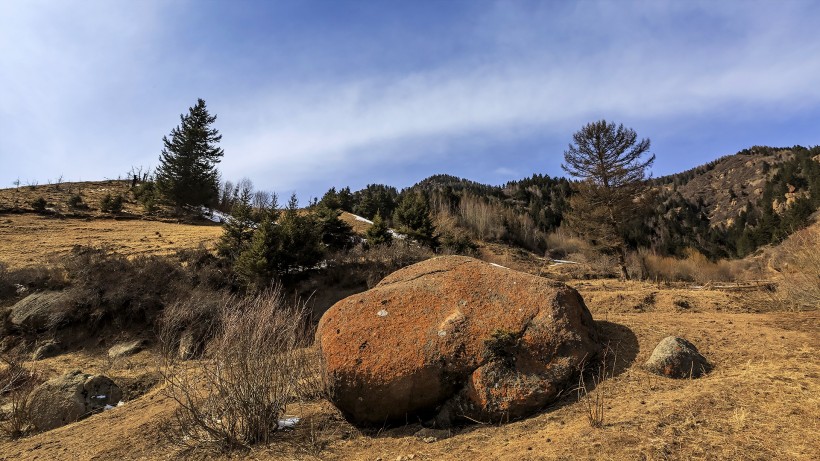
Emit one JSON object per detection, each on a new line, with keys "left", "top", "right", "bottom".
{"left": 320, "top": 146, "right": 820, "bottom": 259}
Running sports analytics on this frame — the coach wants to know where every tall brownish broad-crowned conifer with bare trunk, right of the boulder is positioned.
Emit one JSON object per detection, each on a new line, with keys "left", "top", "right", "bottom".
{"left": 561, "top": 120, "right": 655, "bottom": 279}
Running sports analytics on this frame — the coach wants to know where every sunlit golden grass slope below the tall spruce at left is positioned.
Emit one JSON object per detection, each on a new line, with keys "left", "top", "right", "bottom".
{"left": 0, "top": 213, "right": 222, "bottom": 269}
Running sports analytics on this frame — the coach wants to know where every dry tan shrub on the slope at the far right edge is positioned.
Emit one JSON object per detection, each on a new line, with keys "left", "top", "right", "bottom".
{"left": 775, "top": 226, "right": 820, "bottom": 309}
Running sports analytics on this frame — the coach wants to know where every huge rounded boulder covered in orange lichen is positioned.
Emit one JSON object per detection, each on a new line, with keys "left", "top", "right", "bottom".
{"left": 317, "top": 256, "right": 600, "bottom": 426}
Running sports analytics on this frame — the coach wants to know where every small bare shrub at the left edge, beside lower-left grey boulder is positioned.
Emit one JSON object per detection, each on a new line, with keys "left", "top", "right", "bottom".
{"left": 0, "top": 354, "right": 41, "bottom": 439}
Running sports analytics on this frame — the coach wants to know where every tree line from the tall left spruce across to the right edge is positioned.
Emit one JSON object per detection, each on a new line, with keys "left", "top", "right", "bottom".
{"left": 144, "top": 99, "right": 820, "bottom": 286}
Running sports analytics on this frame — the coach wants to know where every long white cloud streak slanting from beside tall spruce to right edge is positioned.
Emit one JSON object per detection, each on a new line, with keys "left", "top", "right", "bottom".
{"left": 221, "top": 2, "right": 820, "bottom": 190}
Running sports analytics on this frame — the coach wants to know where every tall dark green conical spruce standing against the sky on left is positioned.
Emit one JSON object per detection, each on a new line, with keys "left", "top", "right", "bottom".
{"left": 156, "top": 99, "right": 223, "bottom": 212}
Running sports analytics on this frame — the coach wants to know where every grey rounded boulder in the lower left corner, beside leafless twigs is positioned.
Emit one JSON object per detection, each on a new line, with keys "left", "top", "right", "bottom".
{"left": 29, "top": 371, "right": 122, "bottom": 431}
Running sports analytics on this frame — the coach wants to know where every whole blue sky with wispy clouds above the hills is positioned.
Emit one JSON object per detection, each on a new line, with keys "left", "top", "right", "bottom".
{"left": 0, "top": 0, "right": 820, "bottom": 200}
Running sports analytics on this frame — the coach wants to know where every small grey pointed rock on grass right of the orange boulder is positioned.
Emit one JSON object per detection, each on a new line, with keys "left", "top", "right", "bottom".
{"left": 644, "top": 336, "right": 712, "bottom": 378}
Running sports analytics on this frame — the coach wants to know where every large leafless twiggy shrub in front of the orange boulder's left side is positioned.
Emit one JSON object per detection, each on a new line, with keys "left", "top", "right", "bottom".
{"left": 162, "top": 287, "right": 324, "bottom": 450}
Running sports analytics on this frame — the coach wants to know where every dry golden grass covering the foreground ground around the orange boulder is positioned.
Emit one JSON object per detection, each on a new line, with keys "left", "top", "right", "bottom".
{"left": 0, "top": 302, "right": 820, "bottom": 460}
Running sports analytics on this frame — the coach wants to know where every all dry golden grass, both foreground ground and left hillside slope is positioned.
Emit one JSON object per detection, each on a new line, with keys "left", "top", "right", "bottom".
{"left": 0, "top": 182, "right": 820, "bottom": 461}
